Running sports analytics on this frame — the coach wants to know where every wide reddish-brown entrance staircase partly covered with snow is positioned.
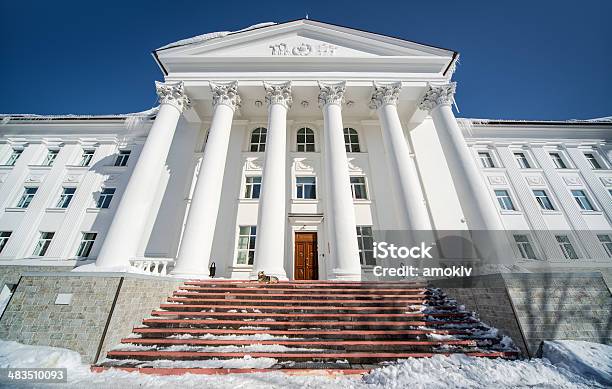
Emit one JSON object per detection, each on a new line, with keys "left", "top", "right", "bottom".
{"left": 94, "top": 280, "right": 519, "bottom": 374}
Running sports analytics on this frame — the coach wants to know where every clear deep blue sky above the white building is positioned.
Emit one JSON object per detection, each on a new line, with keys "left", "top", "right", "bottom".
{"left": 0, "top": 0, "right": 612, "bottom": 119}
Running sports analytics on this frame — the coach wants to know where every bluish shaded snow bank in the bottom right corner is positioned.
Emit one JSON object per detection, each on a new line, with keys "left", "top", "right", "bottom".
{"left": 542, "top": 340, "right": 612, "bottom": 387}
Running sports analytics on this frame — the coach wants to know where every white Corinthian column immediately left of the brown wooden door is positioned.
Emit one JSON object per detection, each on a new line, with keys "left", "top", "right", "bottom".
{"left": 251, "top": 82, "right": 292, "bottom": 279}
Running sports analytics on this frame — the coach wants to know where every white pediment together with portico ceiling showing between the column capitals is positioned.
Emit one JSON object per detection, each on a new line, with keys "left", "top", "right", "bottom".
{"left": 153, "top": 19, "right": 457, "bottom": 119}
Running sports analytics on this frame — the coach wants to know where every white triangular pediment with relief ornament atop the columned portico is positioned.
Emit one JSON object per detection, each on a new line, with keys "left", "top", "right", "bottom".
{"left": 155, "top": 20, "right": 455, "bottom": 76}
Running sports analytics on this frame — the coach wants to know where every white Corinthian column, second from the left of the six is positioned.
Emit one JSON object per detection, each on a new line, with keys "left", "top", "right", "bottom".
{"left": 172, "top": 82, "right": 240, "bottom": 277}
